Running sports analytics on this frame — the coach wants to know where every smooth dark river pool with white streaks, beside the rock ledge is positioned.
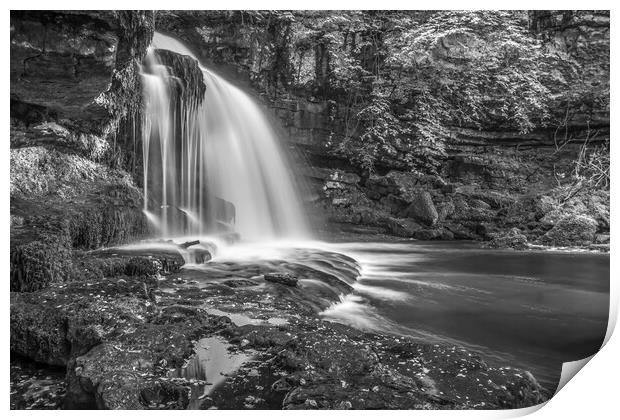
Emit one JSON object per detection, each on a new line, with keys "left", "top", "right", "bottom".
{"left": 323, "top": 242, "right": 609, "bottom": 390}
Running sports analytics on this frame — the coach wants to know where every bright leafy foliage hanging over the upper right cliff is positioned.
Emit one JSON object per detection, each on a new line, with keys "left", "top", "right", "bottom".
{"left": 286, "top": 11, "right": 568, "bottom": 170}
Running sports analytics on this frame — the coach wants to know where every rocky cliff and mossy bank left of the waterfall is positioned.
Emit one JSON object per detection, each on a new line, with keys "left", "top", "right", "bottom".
{"left": 10, "top": 11, "right": 153, "bottom": 291}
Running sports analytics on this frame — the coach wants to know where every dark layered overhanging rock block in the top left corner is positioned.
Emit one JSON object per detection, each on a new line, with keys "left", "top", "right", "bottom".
{"left": 11, "top": 12, "right": 119, "bottom": 118}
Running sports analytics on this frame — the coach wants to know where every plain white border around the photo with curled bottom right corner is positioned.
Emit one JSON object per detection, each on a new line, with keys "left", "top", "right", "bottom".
{"left": 0, "top": 0, "right": 620, "bottom": 419}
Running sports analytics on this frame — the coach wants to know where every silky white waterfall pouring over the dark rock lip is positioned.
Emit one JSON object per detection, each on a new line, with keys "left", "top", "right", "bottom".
{"left": 142, "top": 32, "right": 307, "bottom": 240}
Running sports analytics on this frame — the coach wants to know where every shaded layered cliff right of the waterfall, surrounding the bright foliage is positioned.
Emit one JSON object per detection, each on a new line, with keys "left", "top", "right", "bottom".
{"left": 156, "top": 11, "right": 609, "bottom": 241}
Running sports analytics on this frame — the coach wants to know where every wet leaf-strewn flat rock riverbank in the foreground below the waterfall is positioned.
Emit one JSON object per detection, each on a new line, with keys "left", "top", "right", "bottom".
{"left": 11, "top": 241, "right": 548, "bottom": 409}
